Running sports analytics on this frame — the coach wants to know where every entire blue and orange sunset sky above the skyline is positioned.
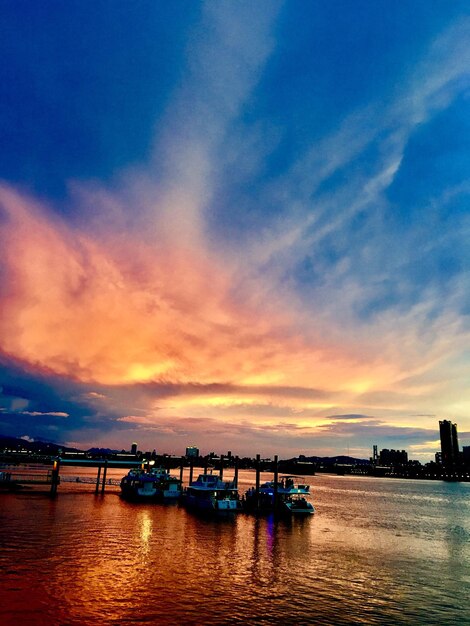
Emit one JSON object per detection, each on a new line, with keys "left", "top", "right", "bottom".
{"left": 0, "top": 0, "right": 470, "bottom": 462}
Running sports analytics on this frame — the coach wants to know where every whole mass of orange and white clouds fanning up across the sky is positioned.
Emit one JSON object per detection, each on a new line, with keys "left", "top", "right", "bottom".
{"left": 0, "top": 3, "right": 470, "bottom": 449}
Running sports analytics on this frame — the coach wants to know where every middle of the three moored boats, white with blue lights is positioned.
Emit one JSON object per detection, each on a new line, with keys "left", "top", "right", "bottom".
{"left": 184, "top": 473, "right": 241, "bottom": 513}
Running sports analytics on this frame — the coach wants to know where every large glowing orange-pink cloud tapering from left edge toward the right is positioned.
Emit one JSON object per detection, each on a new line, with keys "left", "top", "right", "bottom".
{"left": 0, "top": 187, "right": 418, "bottom": 409}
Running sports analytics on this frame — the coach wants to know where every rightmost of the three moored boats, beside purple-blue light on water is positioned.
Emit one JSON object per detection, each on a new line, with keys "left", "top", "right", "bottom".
{"left": 244, "top": 476, "right": 315, "bottom": 515}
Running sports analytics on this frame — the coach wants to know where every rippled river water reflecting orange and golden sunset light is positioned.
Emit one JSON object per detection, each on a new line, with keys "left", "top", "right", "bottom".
{"left": 0, "top": 468, "right": 470, "bottom": 626}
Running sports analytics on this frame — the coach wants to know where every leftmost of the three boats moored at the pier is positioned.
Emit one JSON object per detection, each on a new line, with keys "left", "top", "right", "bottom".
{"left": 121, "top": 467, "right": 182, "bottom": 502}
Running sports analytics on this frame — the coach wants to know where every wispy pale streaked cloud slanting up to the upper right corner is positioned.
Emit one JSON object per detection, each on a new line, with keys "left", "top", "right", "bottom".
{"left": 241, "top": 20, "right": 469, "bottom": 308}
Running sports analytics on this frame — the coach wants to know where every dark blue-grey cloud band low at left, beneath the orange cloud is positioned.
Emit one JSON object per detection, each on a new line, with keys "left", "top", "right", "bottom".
{"left": 0, "top": 355, "right": 334, "bottom": 445}
